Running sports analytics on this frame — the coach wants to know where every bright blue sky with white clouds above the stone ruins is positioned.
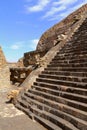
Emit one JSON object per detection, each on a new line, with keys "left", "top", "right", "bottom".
{"left": 0, "top": 0, "right": 87, "bottom": 62}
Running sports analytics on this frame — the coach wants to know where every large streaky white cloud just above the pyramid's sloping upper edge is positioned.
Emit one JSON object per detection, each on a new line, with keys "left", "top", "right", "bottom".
{"left": 42, "top": 0, "right": 87, "bottom": 21}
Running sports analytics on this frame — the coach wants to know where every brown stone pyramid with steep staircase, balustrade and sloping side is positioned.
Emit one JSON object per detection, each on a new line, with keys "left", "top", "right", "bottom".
{"left": 5, "top": 4, "right": 87, "bottom": 130}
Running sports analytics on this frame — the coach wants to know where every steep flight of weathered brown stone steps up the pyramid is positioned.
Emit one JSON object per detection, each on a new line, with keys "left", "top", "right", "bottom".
{"left": 15, "top": 18, "right": 87, "bottom": 130}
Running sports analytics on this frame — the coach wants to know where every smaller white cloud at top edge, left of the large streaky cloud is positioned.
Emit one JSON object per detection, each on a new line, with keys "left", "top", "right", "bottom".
{"left": 26, "top": 0, "right": 50, "bottom": 12}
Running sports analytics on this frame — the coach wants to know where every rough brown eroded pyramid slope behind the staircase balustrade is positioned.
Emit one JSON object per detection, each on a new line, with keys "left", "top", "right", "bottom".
{"left": 37, "top": 4, "right": 87, "bottom": 51}
